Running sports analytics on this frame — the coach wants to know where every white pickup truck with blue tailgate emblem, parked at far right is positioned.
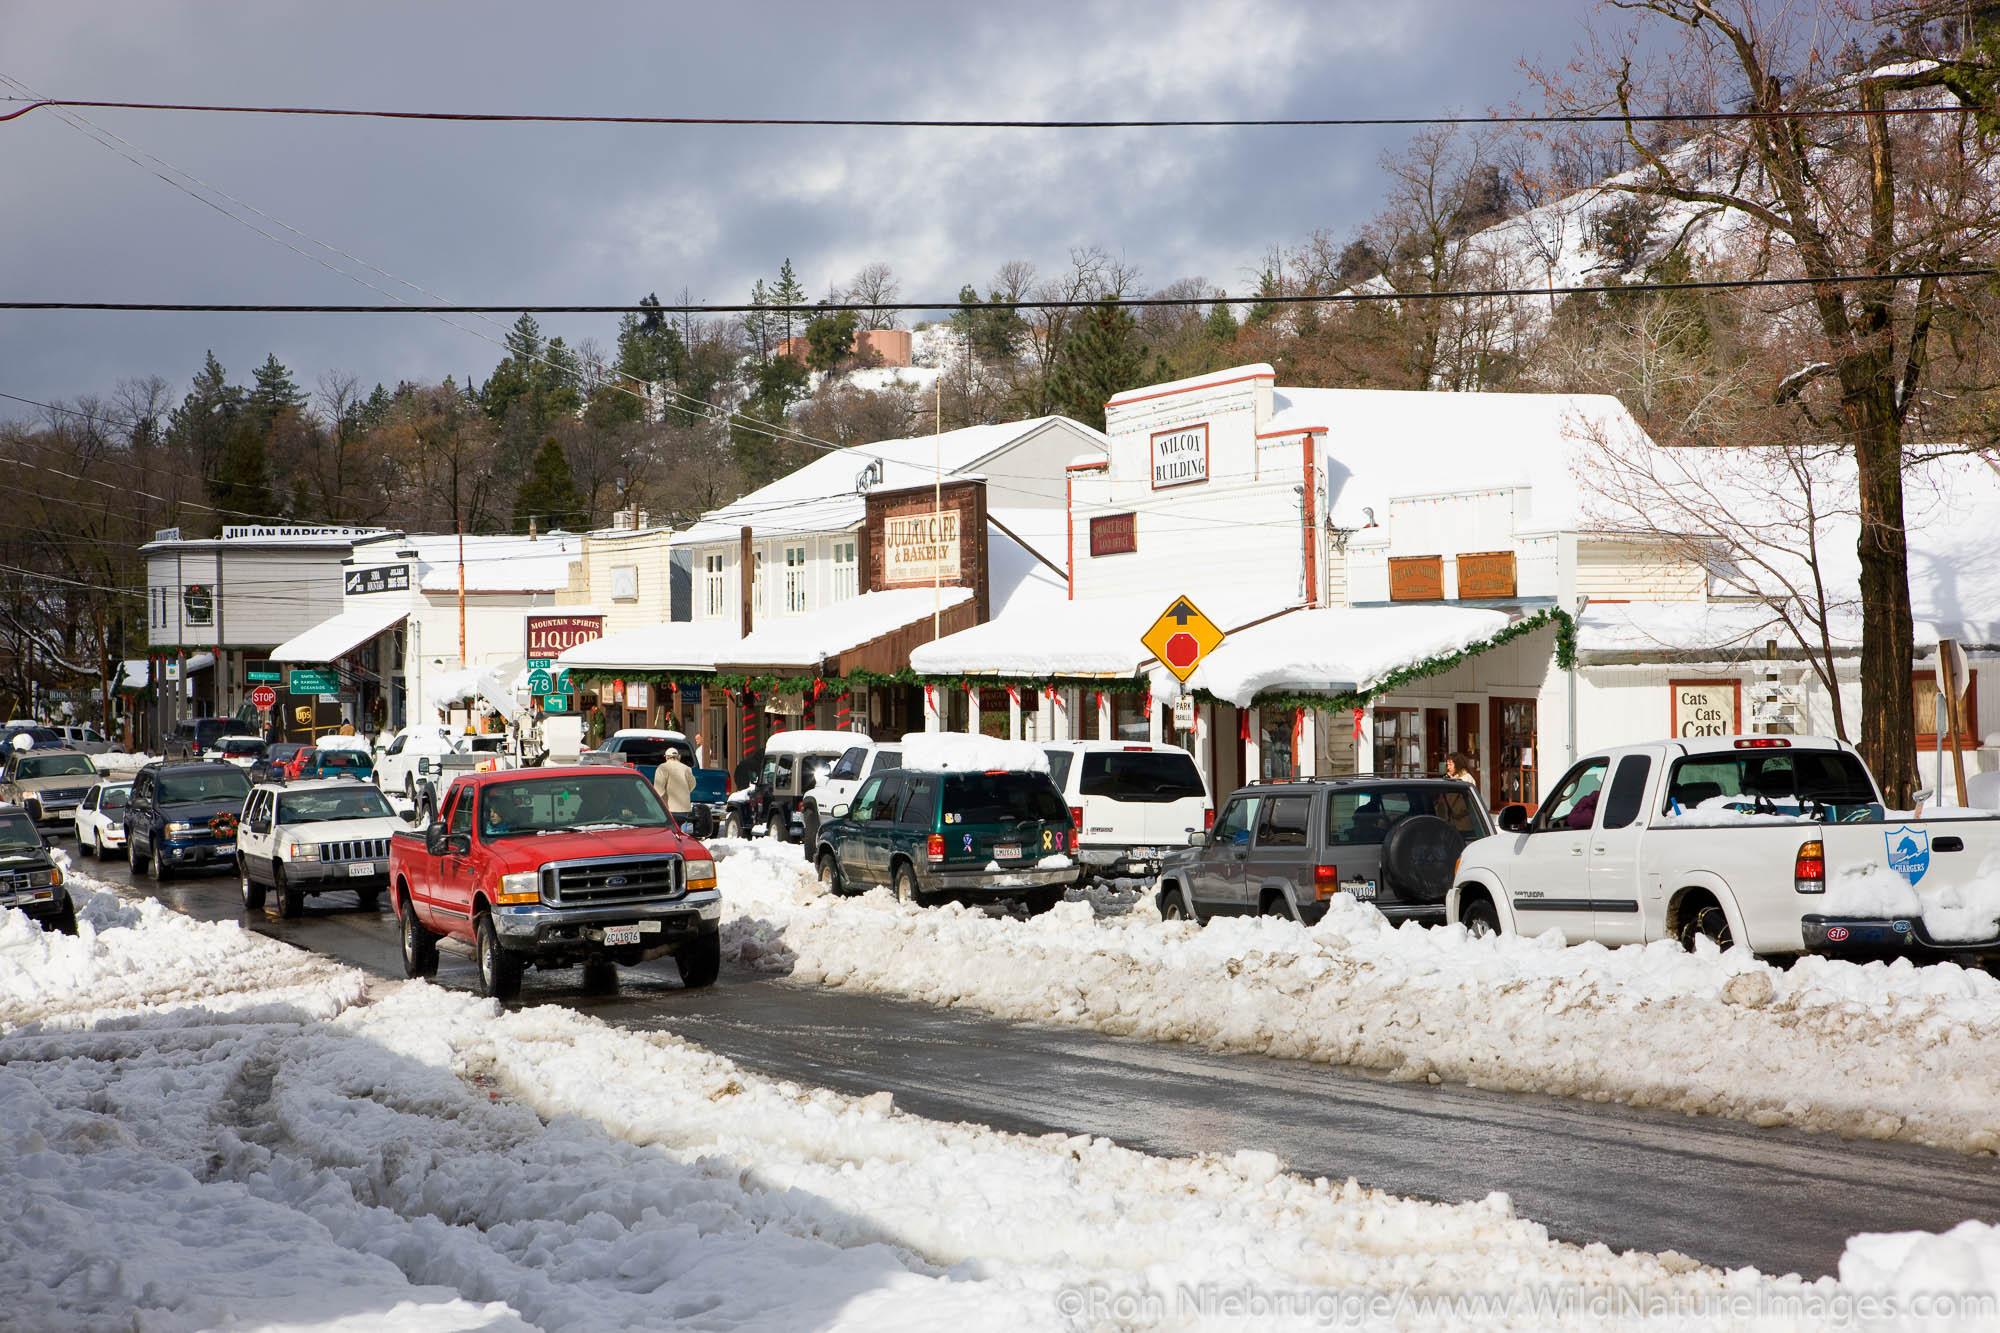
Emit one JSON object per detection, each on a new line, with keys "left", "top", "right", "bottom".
{"left": 1446, "top": 737, "right": 2000, "bottom": 957}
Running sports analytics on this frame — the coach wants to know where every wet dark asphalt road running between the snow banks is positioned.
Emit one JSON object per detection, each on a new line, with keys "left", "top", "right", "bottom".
{"left": 66, "top": 843, "right": 2000, "bottom": 1277}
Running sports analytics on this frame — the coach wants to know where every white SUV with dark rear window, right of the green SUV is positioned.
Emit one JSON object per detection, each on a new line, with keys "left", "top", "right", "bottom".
{"left": 1042, "top": 741, "right": 1216, "bottom": 879}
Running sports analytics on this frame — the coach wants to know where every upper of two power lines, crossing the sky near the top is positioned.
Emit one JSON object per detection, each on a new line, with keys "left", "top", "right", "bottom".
{"left": 0, "top": 98, "right": 1992, "bottom": 130}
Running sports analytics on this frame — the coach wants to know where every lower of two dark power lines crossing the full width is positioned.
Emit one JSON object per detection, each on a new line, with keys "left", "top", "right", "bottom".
{"left": 0, "top": 266, "right": 2000, "bottom": 314}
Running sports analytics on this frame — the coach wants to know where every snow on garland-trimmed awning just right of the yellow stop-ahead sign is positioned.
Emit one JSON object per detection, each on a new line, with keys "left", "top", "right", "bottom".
{"left": 1188, "top": 606, "right": 1508, "bottom": 709}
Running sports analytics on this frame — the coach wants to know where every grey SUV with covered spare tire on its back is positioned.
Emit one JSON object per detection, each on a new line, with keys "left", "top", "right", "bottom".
{"left": 1160, "top": 775, "right": 1492, "bottom": 925}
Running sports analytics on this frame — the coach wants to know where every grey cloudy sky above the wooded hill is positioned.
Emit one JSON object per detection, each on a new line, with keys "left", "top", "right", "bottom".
{"left": 0, "top": 0, "right": 1588, "bottom": 418}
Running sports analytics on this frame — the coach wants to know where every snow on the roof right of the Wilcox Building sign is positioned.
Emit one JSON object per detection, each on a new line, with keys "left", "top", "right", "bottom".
{"left": 1260, "top": 388, "right": 1644, "bottom": 530}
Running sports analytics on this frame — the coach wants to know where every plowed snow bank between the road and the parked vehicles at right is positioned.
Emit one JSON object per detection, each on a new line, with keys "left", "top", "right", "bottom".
{"left": 712, "top": 843, "right": 2000, "bottom": 1153}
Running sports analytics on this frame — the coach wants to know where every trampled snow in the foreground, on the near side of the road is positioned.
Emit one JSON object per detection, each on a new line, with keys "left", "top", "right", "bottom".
{"left": 11, "top": 876, "right": 2000, "bottom": 1331}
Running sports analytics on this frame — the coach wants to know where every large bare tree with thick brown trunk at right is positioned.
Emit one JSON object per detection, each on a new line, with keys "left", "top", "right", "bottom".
{"left": 1538, "top": 0, "right": 2000, "bottom": 803}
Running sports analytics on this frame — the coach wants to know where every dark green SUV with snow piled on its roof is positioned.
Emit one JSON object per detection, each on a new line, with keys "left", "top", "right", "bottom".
{"left": 812, "top": 769, "right": 1080, "bottom": 913}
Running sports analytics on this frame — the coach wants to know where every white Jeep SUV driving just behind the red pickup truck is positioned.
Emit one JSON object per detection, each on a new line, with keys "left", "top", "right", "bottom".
{"left": 236, "top": 781, "right": 404, "bottom": 917}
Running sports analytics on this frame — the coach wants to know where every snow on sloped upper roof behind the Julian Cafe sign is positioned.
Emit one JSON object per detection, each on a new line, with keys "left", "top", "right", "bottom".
{"left": 674, "top": 416, "right": 1094, "bottom": 546}
